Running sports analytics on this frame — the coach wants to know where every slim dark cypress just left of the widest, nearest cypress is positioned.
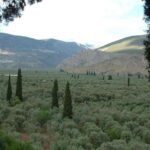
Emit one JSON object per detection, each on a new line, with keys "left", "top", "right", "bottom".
{"left": 52, "top": 79, "right": 59, "bottom": 108}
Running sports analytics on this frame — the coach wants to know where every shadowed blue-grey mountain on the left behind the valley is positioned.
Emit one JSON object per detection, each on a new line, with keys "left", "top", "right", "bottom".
{"left": 0, "top": 33, "right": 86, "bottom": 69}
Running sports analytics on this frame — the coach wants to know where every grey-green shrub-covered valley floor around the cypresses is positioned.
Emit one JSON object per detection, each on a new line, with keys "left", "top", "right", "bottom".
{"left": 0, "top": 71, "right": 150, "bottom": 150}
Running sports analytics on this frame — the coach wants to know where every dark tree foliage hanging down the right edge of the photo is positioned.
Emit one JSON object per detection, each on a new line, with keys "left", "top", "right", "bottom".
{"left": 144, "top": 0, "right": 150, "bottom": 82}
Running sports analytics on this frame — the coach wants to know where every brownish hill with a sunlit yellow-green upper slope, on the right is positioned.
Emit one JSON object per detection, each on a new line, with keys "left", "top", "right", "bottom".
{"left": 57, "top": 35, "right": 146, "bottom": 74}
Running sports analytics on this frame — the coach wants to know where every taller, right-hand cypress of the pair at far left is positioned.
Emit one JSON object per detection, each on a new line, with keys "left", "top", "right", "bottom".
{"left": 16, "top": 68, "right": 23, "bottom": 101}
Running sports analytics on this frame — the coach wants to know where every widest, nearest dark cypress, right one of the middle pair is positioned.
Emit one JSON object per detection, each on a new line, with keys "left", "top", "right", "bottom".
{"left": 63, "top": 82, "right": 73, "bottom": 119}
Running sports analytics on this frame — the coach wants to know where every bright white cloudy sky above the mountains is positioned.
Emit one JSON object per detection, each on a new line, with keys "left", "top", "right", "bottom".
{"left": 0, "top": 0, "right": 147, "bottom": 47}
